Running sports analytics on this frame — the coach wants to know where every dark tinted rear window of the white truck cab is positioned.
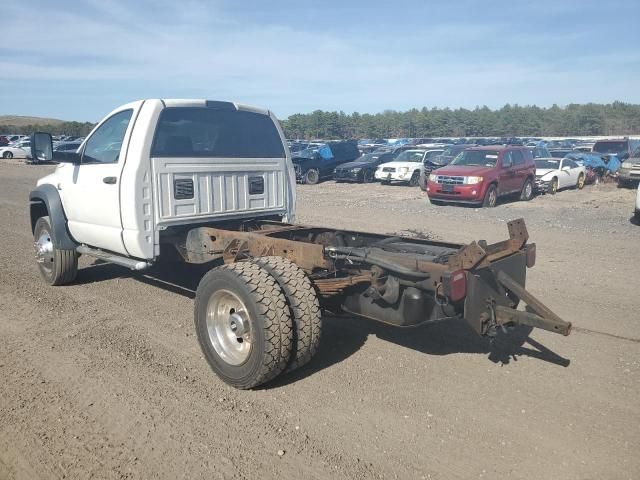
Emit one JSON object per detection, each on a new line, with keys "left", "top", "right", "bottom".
{"left": 151, "top": 107, "right": 285, "bottom": 158}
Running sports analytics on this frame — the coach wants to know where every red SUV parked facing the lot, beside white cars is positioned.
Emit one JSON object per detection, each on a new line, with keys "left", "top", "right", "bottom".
{"left": 427, "top": 146, "right": 536, "bottom": 207}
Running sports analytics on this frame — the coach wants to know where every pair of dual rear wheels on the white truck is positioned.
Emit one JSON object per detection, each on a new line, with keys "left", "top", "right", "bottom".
{"left": 194, "top": 257, "right": 322, "bottom": 389}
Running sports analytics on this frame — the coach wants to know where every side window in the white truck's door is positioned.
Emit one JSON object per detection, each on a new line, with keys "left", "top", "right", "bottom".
{"left": 82, "top": 110, "right": 133, "bottom": 163}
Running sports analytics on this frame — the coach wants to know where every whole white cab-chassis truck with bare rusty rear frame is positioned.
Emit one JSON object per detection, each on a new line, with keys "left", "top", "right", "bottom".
{"left": 30, "top": 100, "right": 571, "bottom": 388}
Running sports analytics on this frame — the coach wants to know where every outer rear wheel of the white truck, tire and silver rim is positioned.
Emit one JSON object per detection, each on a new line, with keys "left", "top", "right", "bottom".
{"left": 194, "top": 262, "right": 293, "bottom": 389}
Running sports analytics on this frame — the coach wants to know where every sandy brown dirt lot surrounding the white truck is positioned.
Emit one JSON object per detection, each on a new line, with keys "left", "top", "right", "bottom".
{"left": 0, "top": 162, "right": 640, "bottom": 480}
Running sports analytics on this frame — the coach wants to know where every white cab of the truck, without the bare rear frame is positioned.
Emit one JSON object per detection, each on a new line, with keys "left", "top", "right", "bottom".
{"left": 32, "top": 99, "right": 295, "bottom": 260}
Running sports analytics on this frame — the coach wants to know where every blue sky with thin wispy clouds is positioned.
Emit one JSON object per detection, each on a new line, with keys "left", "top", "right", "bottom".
{"left": 0, "top": 0, "right": 640, "bottom": 121}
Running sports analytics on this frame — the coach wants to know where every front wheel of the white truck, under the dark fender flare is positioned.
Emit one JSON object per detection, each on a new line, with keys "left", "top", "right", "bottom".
{"left": 33, "top": 217, "right": 78, "bottom": 286}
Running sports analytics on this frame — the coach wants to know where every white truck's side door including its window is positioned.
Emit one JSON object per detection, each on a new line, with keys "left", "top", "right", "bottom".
{"left": 58, "top": 108, "right": 134, "bottom": 255}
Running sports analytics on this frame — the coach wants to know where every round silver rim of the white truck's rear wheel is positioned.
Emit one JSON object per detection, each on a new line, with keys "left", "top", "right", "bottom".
{"left": 207, "top": 290, "right": 251, "bottom": 366}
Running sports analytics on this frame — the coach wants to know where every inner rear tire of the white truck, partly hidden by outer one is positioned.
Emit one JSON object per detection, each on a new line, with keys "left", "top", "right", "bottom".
{"left": 253, "top": 257, "right": 322, "bottom": 372}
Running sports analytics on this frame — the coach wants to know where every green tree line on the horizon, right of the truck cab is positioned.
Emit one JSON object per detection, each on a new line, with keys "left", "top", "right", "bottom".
{"left": 282, "top": 102, "right": 640, "bottom": 139}
